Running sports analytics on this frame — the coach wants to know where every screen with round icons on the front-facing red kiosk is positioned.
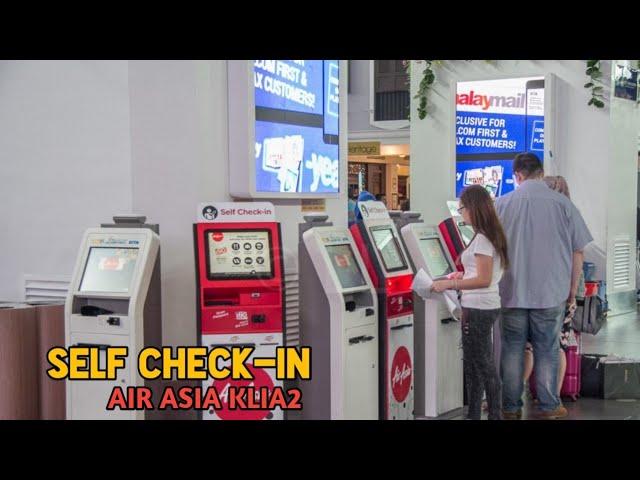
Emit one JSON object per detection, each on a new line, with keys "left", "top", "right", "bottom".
{"left": 205, "top": 230, "right": 273, "bottom": 280}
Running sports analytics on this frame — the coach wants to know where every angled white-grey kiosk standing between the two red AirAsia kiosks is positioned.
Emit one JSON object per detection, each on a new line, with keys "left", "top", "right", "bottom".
{"left": 298, "top": 216, "right": 378, "bottom": 420}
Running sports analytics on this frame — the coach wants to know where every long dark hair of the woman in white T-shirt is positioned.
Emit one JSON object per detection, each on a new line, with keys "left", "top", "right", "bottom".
{"left": 460, "top": 185, "right": 509, "bottom": 270}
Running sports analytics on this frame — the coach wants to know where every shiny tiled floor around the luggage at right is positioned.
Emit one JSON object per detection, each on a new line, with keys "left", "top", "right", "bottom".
{"left": 444, "top": 312, "right": 640, "bottom": 420}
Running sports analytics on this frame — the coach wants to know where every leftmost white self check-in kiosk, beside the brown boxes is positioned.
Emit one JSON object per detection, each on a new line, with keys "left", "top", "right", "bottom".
{"left": 65, "top": 216, "right": 162, "bottom": 420}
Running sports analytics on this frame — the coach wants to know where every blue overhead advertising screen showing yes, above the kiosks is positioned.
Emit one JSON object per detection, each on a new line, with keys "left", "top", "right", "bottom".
{"left": 253, "top": 60, "right": 340, "bottom": 196}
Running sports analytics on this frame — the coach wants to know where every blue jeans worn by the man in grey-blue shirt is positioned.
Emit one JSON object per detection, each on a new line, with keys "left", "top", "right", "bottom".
{"left": 500, "top": 303, "right": 565, "bottom": 412}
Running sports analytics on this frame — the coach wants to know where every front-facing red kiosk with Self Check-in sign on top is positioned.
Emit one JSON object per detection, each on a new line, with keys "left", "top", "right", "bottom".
{"left": 193, "top": 202, "right": 285, "bottom": 420}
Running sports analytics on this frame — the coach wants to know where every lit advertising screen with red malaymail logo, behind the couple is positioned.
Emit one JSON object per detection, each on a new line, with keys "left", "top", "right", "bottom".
{"left": 456, "top": 77, "right": 544, "bottom": 197}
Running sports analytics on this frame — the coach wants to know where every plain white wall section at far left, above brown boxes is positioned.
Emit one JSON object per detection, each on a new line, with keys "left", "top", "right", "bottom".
{"left": 0, "top": 61, "right": 131, "bottom": 300}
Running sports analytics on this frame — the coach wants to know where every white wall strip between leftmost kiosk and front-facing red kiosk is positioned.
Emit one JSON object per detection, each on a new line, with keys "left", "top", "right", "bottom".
{"left": 129, "top": 61, "right": 227, "bottom": 345}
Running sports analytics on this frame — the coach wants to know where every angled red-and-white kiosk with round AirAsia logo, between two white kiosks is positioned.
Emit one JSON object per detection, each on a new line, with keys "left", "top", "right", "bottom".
{"left": 350, "top": 201, "right": 413, "bottom": 420}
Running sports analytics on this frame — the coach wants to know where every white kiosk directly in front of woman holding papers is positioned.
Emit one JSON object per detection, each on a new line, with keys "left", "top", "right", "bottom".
{"left": 402, "top": 223, "right": 463, "bottom": 417}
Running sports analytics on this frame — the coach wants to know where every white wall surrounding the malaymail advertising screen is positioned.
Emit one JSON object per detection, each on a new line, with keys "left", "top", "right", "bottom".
{"left": 411, "top": 60, "right": 609, "bottom": 248}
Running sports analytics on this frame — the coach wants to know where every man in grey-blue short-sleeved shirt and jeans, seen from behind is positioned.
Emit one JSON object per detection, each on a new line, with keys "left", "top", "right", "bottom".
{"left": 496, "top": 153, "right": 593, "bottom": 419}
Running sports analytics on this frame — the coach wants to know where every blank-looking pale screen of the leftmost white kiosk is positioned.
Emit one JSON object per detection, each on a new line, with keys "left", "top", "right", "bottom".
{"left": 80, "top": 247, "right": 139, "bottom": 293}
